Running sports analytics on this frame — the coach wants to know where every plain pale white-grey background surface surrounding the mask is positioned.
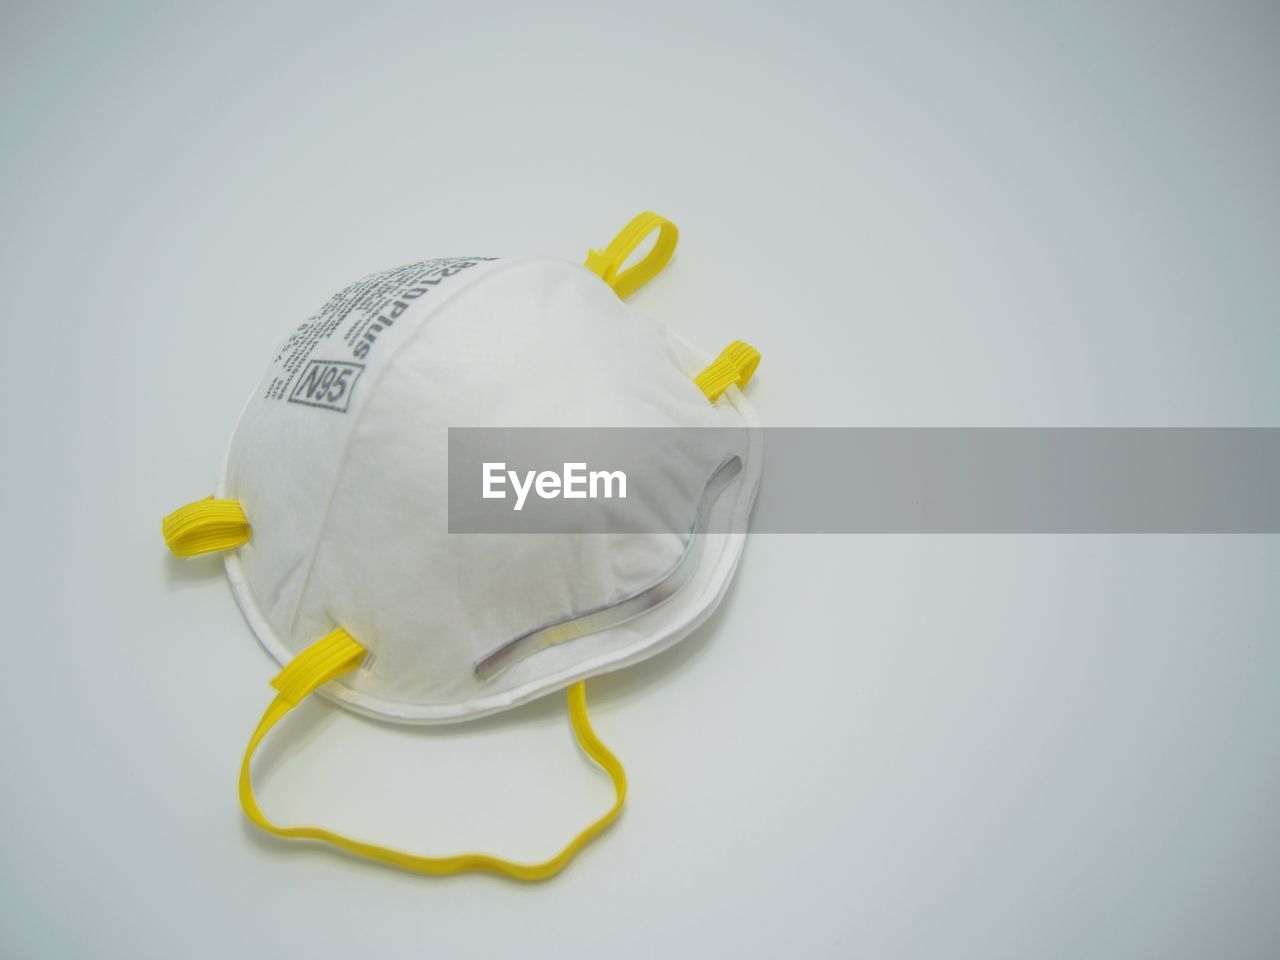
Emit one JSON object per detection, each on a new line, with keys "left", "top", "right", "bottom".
{"left": 0, "top": 1, "right": 1280, "bottom": 959}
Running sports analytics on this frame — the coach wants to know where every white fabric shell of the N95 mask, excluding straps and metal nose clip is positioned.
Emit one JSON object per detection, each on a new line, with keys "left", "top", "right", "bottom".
{"left": 219, "top": 257, "right": 759, "bottom": 722}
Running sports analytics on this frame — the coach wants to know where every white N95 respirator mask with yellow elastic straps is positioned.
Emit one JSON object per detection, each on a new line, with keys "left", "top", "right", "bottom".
{"left": 163, "top": 214, "right": 760, "bottom": 879}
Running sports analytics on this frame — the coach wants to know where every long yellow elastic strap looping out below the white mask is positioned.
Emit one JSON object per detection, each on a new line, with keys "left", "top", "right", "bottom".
{"left": 239, "top": 630, "right": 627, "bottom": 881}
